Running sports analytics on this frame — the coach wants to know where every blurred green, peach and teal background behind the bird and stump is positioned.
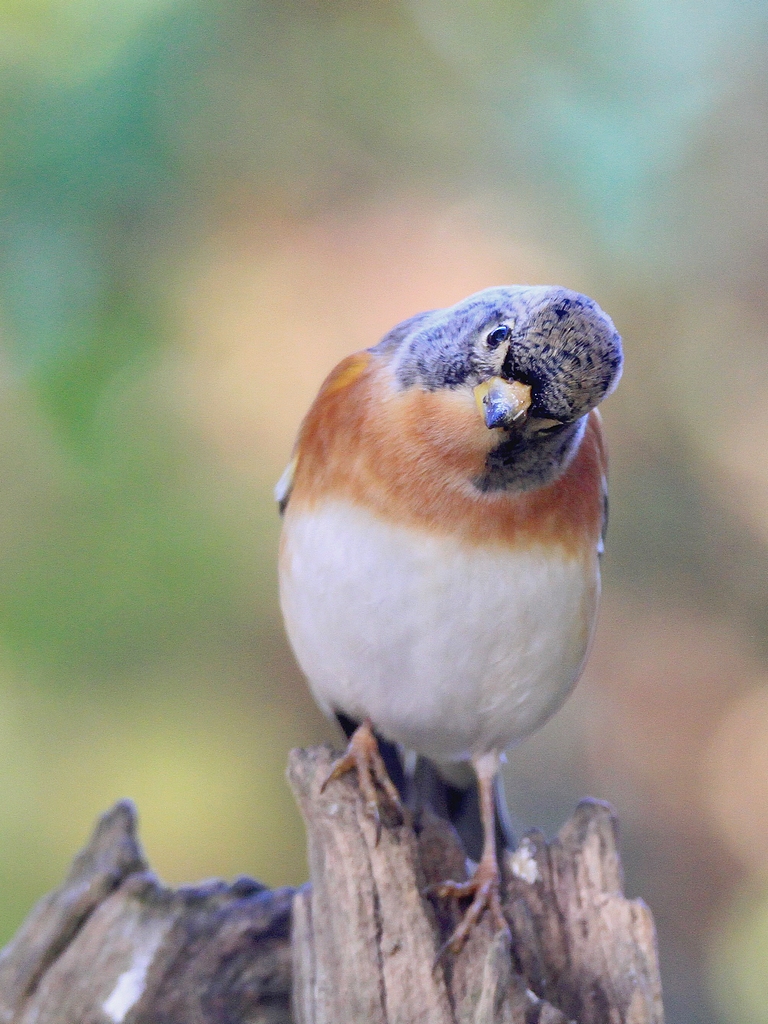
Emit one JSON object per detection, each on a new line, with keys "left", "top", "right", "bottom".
{"left": 0, "top": 0, "right": 768, "bottom": 1024}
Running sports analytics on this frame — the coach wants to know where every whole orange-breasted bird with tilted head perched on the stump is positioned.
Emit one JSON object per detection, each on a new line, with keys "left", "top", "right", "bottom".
{"left": 275, "top": 285, "right": 624, "bottom": 951}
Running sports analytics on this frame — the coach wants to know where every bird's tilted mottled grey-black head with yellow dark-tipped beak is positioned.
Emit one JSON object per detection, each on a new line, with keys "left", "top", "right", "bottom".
{"left": 381, "top": 286, "right": 623, "bottom": 440}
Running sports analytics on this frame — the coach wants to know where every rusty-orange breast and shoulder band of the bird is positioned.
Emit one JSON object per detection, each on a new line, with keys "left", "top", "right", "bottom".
{"left": 288, "top": 352, "right": 606, "bottom": 555}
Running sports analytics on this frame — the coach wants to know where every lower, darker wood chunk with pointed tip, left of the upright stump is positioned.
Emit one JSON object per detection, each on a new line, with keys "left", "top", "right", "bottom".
{"left": 0, "top": 802, "right": 294, "bottom": 1024}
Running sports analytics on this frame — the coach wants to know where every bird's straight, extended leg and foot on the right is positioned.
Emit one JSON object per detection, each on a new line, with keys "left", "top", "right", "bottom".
{"left": 427, "top": 752, "right": 509, "bottom": 959}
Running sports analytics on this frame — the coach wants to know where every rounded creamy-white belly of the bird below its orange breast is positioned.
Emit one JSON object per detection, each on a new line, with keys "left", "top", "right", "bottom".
{"left": 281, "top": 503, "right": 600, "bottom": 761}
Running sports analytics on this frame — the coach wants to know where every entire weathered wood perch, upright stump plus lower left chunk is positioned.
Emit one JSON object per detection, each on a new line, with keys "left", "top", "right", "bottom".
{"left": 0, "top": 749, "right": 664, "bottom": 1024}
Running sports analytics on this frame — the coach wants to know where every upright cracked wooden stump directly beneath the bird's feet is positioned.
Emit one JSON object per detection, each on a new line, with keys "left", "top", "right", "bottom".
{"left": 289, "top": 749, "right": 664, "bottom": 1024}
